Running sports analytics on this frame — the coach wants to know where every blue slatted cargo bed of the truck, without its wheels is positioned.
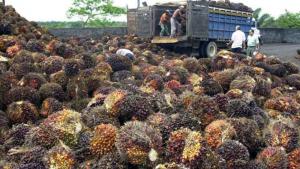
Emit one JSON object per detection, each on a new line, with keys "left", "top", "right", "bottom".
{"left": 128, "top": 0, "right": 255, "bottom": 43}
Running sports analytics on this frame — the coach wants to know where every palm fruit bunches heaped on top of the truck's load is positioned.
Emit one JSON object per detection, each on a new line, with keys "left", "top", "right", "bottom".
{"left": 209, "top": 0, "right": 253, "bottom": 12}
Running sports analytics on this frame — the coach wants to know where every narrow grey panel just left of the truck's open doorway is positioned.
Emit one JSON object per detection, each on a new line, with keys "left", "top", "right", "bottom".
{"left": 137, "top": 7, "right": 152, "bottom": 37}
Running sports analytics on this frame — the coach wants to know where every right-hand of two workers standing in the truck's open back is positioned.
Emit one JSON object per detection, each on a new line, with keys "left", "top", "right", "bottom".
{"left": 171, "top": 6, "right": 184, "bottom": 37}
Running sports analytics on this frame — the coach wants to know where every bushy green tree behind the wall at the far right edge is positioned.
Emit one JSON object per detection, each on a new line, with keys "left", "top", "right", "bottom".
{"left": 276, "top": 11, "right": 300, "bottom": 28}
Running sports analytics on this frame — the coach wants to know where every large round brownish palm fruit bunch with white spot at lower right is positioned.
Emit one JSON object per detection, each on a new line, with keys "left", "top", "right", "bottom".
{"left": 116, "top": 121, "right": 163, "bottom": 165}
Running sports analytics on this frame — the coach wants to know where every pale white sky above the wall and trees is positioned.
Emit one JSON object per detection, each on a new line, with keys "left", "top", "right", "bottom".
{"left": 6, "top": 0, "right": 300, "bottom": 21}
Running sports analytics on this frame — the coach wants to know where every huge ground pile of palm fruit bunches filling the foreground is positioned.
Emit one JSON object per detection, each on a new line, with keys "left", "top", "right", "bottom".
{"left": 0, "top": 3, "right": 300, "bottom": 169}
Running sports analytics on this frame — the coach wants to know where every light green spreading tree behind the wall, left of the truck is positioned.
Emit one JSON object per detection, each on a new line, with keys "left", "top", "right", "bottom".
{"left": 67, "top": 0, "right": 126, "bottom": 26}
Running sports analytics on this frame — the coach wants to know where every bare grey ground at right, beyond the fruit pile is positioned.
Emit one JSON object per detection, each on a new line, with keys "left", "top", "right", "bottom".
{"left": 261, "top": 44, "right": 300, "bottom": 67}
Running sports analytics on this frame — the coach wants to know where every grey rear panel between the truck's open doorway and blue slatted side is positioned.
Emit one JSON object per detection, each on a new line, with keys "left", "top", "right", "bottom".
{"left": 187, "top": 0, "right": 208, "bottom": 39}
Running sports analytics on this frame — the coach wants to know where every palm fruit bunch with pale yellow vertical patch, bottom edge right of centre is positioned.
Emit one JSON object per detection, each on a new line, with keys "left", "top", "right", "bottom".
{"left": 166, "top": 128, "right": 224, "bottom": 169}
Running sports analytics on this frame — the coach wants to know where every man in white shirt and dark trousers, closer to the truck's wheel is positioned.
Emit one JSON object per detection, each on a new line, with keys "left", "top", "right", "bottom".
{"left": 228, "top": 26, "right": 246, "bottom": 53}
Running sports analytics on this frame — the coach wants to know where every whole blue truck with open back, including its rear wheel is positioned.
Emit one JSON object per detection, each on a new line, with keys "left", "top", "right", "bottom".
{"left": 127, "top": 0, "right": 255, "bottom": 57}
